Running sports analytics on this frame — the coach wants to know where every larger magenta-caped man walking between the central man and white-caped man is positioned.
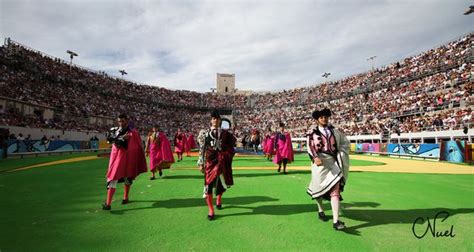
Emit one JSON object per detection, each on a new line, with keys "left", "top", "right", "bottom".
{"left": 273, "top": 122, "right": 295, "bottom": 174}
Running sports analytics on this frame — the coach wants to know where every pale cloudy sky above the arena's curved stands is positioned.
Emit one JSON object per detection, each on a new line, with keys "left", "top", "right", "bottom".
{"left": 0, "top": 0, "right": 474, "bottom": 92}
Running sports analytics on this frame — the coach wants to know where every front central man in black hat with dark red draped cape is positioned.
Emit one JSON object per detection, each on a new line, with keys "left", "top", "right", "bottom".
{"left": 198, "top": 110, "right": 236, "bottom": 220}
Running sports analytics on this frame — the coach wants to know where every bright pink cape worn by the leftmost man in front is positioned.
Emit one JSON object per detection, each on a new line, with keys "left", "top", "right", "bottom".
{"left": 107, "top": 129, "right": 147, "bottom": 182}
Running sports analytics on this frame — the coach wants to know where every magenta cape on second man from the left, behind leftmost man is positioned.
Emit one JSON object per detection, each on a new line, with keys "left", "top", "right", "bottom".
{"left": 149, "top": 132, "right": 174, "bottom": 172}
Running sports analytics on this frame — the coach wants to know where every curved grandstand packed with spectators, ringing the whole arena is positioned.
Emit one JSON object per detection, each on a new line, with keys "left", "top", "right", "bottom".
{"left": 0, "top": 33, "right": 474, "bottom": 142}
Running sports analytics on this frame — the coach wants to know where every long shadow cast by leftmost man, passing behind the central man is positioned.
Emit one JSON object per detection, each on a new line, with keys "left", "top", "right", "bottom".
{"left": 110, "top": 196, "right": 278, "bottom": 215}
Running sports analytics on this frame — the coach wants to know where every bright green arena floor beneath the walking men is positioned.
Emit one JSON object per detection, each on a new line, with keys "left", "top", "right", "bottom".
{"left": 0, "top": 154, "right": 474, "bottom": 251}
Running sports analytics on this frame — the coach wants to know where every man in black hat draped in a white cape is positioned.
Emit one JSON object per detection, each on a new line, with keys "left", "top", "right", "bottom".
{"left": 307, "top": 109, "right": 350, "bottom": 230}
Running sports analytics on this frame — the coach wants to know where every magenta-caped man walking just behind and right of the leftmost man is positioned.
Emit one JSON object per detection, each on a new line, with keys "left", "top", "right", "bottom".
{"left": 146, "top": 126, "right": 174, "bottom": 180}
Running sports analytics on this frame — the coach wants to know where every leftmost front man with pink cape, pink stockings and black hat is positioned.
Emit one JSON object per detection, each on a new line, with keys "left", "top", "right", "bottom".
{"left": 102, "top": 114, "right": 147, "bottom": 210}
